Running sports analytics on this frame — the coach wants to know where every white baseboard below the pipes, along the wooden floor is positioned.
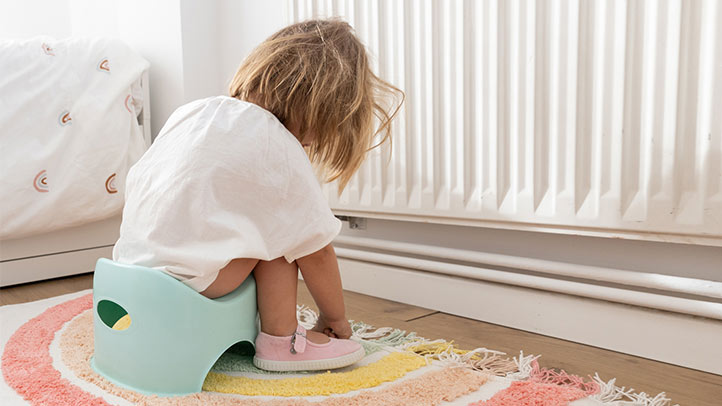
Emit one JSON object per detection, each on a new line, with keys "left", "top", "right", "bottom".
{"left": 339, "top": 257, "right": 722, "bottom": 375}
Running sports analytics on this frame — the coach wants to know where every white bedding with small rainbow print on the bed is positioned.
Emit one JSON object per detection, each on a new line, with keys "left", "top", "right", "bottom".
{"left": 0, "top": 38, "right": 149, "bottom": 239}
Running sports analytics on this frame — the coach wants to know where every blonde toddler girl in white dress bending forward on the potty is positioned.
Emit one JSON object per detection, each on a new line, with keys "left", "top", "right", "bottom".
{"left": 113, "top": 20, "right": 403, "bottom": 371}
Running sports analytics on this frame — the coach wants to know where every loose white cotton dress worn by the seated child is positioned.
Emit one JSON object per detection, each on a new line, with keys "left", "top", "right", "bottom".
{"left": 113, "top": 96, "right": 341, "bottom": 292}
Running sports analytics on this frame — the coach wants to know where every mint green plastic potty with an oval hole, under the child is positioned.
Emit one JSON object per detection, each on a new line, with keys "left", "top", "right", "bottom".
{"left": 90, "top": 258, "right": 259, "bottom": 396}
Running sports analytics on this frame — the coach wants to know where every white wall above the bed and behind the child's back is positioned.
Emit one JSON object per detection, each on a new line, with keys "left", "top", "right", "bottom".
{"left": 0, "top": 0, "right": 286, "bottom": 137}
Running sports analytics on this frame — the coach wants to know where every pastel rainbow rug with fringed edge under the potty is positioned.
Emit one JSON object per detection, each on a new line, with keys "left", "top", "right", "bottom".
{"left": 0, "top": 290, "right": 671, "bottom": 406}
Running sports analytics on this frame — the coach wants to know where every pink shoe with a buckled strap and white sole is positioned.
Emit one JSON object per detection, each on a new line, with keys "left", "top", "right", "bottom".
{"left": 253, "top": 324, "right": 366, "bottom": 371}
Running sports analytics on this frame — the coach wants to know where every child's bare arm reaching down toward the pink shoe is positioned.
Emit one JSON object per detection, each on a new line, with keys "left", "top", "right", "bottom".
{"left": 296, "top": 244, "right": 351, "bottom": 338}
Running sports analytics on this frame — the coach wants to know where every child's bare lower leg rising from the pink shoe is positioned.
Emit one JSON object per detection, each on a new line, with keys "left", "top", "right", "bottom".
{"left": 253, "top": 257, "right": 329, "bottom": 344}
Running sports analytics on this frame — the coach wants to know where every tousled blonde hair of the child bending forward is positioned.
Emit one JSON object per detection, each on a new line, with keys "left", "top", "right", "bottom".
{"left": 230, "top": 19, "right": 405, "bottom": 195}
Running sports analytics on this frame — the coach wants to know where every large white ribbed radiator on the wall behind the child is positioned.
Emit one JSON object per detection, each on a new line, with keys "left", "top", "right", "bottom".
{"left": 287, "top": 0, "right": 722, "bottom": 246}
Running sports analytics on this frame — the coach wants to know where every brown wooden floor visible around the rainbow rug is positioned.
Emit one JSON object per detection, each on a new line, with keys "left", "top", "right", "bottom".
{"left": 0, "top": 274, "right": 722, "bottom": 406}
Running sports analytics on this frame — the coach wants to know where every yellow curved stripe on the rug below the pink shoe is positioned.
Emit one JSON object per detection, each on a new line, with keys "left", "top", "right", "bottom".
{"left": 203, "top": 352, "right": 426, "bottom": 396}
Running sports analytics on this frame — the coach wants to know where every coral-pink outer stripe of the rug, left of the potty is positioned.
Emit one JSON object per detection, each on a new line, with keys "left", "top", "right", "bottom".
{"left": 2, "top": 293, "right": 109, "bottom": 406}
